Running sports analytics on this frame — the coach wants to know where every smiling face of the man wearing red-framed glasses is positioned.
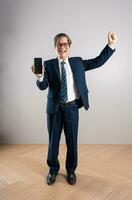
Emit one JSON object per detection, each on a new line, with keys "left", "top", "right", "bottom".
{"left": 55, "top": 37, "right": 70, "bottom": 60}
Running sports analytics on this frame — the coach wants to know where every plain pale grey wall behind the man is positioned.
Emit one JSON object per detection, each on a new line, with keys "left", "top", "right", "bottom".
{"left": 0, "top": 0, "right": 132, "bottom": 144}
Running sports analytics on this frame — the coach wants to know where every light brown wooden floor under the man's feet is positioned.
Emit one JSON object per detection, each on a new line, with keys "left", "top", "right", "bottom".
{"left": 0, "top": 145, "right": 132, "bottom": 200}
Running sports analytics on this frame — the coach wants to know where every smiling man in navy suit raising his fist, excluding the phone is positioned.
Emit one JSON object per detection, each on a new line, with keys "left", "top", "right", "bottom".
{"left": 32, "top": 32, "right": 117, "bottom": 185}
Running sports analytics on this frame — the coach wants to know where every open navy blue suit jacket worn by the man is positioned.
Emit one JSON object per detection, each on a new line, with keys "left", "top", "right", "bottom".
{"left": 36, "top": 45, "right": 115, "bottom": 114}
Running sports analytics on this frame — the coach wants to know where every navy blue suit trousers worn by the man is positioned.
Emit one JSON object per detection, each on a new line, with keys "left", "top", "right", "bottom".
{"left": 47, "top": 101, "right": 79, "bottom": 174}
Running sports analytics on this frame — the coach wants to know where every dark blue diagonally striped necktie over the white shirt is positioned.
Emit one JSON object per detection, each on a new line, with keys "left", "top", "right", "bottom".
{"left": 60, "top": 61, "right": 68, "bottom": 103}
